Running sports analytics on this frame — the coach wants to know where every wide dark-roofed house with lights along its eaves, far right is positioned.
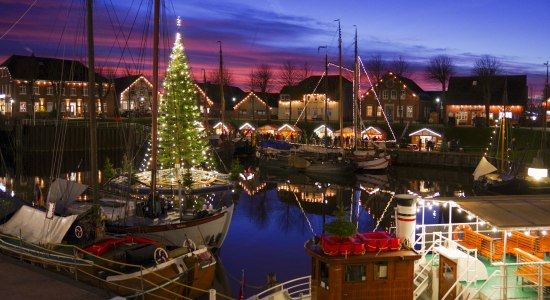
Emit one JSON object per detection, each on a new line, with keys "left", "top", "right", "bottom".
{"left": 445, "top": 75, "right": 528, "bottom": 125}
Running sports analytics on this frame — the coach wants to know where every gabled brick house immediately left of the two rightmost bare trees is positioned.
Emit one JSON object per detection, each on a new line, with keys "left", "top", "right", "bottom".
{"left": 361, "top": 72, "right": 433, "bottom": 122}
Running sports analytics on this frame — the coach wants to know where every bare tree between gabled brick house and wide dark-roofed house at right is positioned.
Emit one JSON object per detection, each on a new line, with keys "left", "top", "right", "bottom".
{"left": 426, "top": 55, "right": 455, "bottom": 122}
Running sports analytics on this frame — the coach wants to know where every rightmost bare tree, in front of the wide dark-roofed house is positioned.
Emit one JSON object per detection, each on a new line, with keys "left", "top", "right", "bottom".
{"left": 472, "top": 55, "right": 502, "bottom": 126}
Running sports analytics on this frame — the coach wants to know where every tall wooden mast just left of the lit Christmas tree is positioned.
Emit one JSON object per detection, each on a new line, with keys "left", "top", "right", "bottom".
{"left": 151, "top": 0, "right": 160, "bottom": 200}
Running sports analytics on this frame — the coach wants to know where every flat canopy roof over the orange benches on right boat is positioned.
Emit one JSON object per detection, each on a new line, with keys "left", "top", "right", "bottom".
{"left": 434, "top": 195, "right": 550, "bottom": 229}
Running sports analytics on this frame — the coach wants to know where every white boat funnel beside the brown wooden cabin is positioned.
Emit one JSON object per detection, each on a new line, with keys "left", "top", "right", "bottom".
{"left": 394, "top": 194, "right": 416, "bottom": 248}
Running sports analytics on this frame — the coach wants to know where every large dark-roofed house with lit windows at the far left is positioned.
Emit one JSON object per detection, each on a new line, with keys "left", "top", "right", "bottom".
{"left": 0, "top": 55, "right": 115, "bottom": 117}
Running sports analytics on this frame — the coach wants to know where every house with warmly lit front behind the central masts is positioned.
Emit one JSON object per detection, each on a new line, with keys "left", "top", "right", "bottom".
{"left": 278, "top": 75, "right": 353, "bottom": 122}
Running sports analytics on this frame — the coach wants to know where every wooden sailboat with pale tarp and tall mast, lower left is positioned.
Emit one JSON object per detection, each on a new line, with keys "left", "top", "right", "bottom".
{"left": 0, "top": 0, "right": 220, "bottom": 299}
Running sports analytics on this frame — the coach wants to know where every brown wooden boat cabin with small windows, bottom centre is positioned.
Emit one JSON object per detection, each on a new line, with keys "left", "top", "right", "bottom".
{"left": 305, "top": 237, "right": 420, "bottom": 300}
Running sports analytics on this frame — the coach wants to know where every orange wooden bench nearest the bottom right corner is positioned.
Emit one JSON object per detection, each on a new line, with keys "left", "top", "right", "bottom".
{"left": 513, "top": 248, "right": 550, "bottom": 287}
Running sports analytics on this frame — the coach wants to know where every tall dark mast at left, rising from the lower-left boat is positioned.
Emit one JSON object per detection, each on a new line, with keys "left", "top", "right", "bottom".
{"left": 86, "top": 0, "right": 99, "bottom": 214}
